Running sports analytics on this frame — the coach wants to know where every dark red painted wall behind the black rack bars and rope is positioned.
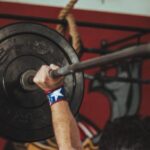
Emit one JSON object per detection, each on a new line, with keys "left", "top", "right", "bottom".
{"left": 0, "top": 2, "right": 150, "bottom": 148}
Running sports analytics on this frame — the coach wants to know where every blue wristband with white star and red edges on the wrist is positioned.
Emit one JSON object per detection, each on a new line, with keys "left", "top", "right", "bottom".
{"left": 47, "top": 86, "right": 65, "bottom": 106}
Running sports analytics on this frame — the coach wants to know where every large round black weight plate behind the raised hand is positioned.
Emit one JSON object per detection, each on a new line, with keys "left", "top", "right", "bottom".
{"left": 0, "top": 23, "right": 83, "bottom": 142}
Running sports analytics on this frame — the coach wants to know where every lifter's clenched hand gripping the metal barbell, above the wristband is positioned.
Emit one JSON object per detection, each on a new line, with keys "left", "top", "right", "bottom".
{"left": 33, "top": 64, "right": 63, "bottom": 92}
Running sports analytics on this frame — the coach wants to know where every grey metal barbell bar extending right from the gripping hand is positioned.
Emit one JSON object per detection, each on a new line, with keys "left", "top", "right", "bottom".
{"left": 50, "top": 44, "right": 150, "bottom": 78}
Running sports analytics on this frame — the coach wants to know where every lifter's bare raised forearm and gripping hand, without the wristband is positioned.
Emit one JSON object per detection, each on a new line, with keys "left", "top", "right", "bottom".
{"left": 33, "top": 65, "right": 82, "bottom": 150}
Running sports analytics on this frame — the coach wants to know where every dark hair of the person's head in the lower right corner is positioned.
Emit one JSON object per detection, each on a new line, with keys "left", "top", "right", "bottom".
{"left": 99, "top": 116, "right": 150, "bottom": 150}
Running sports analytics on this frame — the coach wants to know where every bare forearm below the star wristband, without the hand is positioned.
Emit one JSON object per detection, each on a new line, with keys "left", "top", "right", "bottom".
{"left": 51, "top": 101, "right": 81, "bottom": 150}
